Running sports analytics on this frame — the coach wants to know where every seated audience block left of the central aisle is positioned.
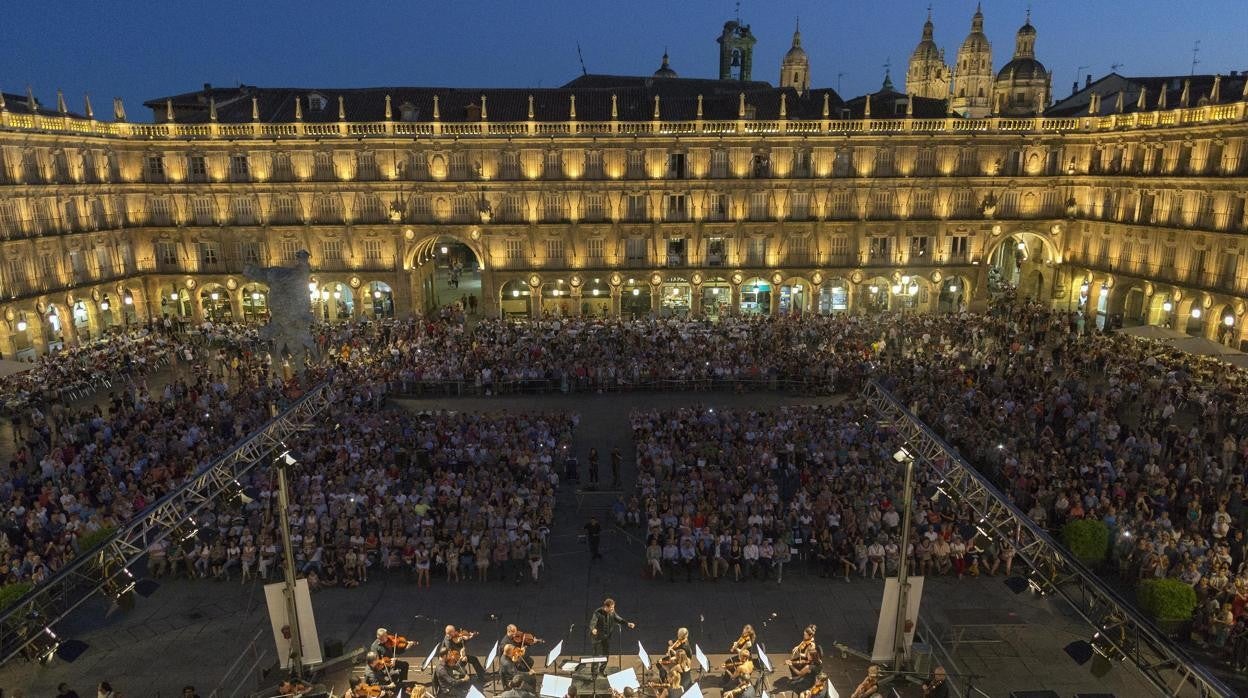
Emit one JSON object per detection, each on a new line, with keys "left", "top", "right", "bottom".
{"left": 149, "top": 401, "right": 575, "bottom": 589}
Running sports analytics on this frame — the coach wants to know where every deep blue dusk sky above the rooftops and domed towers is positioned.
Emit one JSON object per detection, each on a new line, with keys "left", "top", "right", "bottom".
{"left": 0, "top": 0, "right": 1248, "bottom": 121}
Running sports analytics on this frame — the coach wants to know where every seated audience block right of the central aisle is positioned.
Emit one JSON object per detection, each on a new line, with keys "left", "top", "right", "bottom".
{"left": 633, "top": 400, "right": 1013, "bottom": 582}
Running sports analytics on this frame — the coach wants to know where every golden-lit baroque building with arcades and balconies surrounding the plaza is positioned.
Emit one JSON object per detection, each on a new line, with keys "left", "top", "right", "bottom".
{"left": 0, "top": 32, "right": 1248, "bottom": 358}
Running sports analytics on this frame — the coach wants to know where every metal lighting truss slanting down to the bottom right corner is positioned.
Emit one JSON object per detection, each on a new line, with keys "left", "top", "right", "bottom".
{"left": 862, "top": 381, "right": 1236, "bottom": 698}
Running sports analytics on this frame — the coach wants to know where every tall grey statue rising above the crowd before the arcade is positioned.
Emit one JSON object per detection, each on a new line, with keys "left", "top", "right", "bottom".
{"left": 242, "top": 250, "right": 319, "bottom": 375}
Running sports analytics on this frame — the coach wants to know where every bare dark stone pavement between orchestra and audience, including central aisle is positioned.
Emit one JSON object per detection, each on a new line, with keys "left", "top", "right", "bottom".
{"left": 0, "top": 393, "right": 1152, "bottom": 698}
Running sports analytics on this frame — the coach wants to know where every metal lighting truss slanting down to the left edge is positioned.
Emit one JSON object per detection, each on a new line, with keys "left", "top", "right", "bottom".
{"left": 0, "top": 383, "right": 331, "bottom": 664}
